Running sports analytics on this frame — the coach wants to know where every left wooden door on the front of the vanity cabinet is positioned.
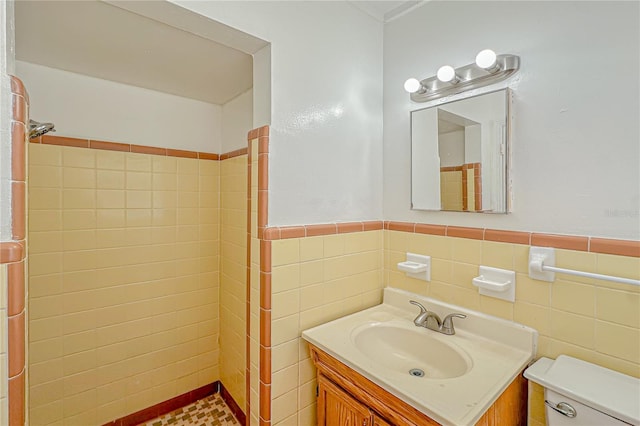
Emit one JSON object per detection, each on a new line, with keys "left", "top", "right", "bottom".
{"left": 318, "top": 375, "right": 373, "bottom": 426}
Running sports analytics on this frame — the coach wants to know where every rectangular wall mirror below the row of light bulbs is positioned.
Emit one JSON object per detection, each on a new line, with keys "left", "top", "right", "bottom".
{"left": 411, "top": 89, "right": 510, "bottom": 213}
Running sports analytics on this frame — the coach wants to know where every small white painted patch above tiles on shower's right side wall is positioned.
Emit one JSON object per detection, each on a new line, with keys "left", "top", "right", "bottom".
{"left": 220, "top": 90, "right": 253, "bottom": 153}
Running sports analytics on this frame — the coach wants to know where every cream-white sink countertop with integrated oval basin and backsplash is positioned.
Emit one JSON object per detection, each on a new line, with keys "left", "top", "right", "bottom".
{"left": 302, "top": 288, "right": 538, "bottom": 426}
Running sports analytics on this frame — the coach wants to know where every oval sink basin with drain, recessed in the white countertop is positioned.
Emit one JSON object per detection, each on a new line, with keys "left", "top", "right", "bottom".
{"left": 351, "top": 324, "right": 472, "bottom": 379}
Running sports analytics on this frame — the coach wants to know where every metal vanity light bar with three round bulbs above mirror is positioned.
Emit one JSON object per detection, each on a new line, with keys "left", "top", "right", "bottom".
{"left": 404, "top": 49, "right": 520, "bottom": 102}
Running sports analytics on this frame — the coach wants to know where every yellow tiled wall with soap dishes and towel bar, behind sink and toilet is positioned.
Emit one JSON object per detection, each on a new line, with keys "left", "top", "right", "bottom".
{"left": 384, "top": 223, "right": 640, "bottom": 425}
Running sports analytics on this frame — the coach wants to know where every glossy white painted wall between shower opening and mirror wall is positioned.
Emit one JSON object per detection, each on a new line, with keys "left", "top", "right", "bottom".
{"left": 173, "top": 1, "right": 382, "bottom": 225}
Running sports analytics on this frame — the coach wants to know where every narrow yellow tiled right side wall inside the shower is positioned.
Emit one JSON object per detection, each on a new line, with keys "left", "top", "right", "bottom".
{"left": 220, "top": 150, "right": 247, "bottom": 410}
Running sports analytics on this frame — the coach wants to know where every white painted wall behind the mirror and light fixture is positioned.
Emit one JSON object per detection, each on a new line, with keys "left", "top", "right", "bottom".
{"left": 384, "top": 1, "right": 640, "bottom": 239}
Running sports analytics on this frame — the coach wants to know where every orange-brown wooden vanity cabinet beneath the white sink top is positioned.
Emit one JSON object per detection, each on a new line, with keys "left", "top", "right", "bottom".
{"left": 310, "top": 345, "right": 527, "bottom": 426}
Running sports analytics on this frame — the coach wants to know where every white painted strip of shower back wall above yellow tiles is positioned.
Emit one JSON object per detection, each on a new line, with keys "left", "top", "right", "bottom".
{"left": 16, "top": 61, "right": 224, "bottom": 153}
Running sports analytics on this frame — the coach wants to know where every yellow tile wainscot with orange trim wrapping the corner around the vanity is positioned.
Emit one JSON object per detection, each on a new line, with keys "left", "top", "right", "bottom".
{"left": 252, "top": 222, "right": 640, "bottom": 426}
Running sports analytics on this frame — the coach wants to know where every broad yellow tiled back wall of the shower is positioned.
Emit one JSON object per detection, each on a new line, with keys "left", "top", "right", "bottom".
{"left": 29, "top": 141, "right": 220, "bottom": 425}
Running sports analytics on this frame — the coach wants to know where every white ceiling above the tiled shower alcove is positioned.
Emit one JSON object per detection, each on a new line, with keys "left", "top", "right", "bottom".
{"left": 15, "top": 0, "right": 258, "bottom": 104}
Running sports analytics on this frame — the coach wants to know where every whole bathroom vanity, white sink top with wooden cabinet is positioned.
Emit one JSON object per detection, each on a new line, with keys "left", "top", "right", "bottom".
{"left": 302, "top": 288, "right": 537, "bottom": 426}
